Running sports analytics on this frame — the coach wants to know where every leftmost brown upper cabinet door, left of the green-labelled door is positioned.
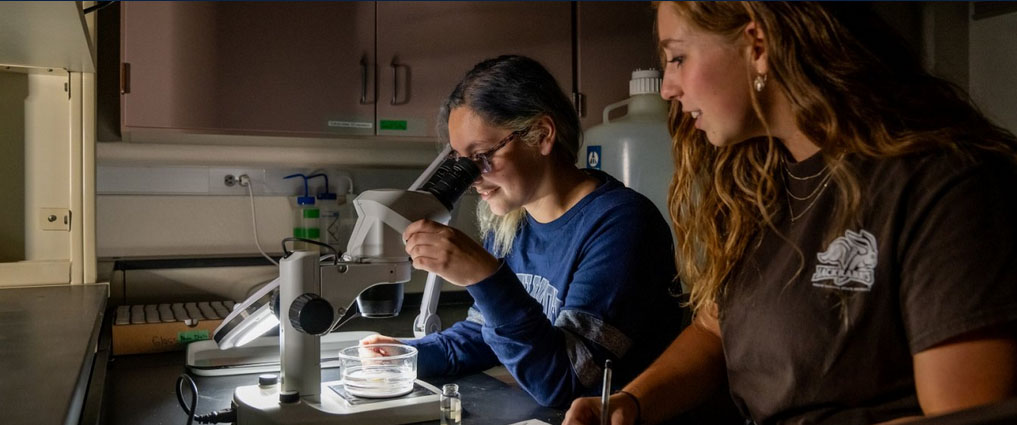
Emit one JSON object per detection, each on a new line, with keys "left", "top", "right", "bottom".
{"left": 120, "top": 2, "right": 374, "bottom": 136}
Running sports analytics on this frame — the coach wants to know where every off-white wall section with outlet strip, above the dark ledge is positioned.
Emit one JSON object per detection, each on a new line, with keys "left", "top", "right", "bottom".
{"left": 96, "top": 166, "right": 431, "bottom": 257}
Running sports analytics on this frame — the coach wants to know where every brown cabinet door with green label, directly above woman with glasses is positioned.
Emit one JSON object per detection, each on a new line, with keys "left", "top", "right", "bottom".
{"left": 377, "top": 1, "right": 573, "bottom": 136}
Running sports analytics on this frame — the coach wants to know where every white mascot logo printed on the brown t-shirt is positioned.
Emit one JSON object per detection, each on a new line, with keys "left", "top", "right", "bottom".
{"left": 813, "top": 230, "right": 879, "bottom": 291}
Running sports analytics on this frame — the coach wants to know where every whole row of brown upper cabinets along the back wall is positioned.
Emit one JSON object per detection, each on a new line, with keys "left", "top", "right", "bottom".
{"left": 120, "top": 1, "right": 655, "bottom": 139}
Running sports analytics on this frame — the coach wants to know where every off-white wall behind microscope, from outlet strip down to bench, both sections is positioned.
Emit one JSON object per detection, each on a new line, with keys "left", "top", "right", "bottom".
{"left": 96, "top": 165, "right": 478, "bottom": 304}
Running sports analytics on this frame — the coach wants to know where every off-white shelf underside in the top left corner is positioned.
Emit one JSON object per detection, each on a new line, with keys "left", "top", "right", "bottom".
{"left": 0, "top": 1, "right": 96, "bottom": 72}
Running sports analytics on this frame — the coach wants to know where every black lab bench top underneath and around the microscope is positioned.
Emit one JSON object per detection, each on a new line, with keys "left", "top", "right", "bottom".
{"left": 104, "top": 302, "right": 564, "bottom": 425}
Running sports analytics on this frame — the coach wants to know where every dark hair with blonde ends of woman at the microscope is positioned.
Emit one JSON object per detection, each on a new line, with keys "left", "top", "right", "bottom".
{"left": 437, "top": 55, "right": 582, "bottom": 256}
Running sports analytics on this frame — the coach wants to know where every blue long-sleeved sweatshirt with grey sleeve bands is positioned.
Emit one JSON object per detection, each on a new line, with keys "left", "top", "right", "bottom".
{"left": 406, "top": 170, "right": 685, "bottom": 407}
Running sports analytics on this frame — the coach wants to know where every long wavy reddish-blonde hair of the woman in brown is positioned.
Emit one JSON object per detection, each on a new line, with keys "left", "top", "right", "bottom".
{"left": 655, "top": 2, "right": 1017, "bottom": 311}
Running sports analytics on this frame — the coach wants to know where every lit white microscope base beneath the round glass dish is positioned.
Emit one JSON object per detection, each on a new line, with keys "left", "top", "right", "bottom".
{"left": 233, "top": 380, "right": 441, "bottom": 425}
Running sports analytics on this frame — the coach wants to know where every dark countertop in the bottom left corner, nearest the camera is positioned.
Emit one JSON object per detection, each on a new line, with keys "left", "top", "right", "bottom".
{"left": 0, "top": 285, "right": 109, "bottom": 425}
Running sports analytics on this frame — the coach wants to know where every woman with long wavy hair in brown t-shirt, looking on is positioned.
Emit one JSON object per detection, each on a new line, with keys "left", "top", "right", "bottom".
{"left": 565, "top": 2, "right": 1017, "bottom": 425}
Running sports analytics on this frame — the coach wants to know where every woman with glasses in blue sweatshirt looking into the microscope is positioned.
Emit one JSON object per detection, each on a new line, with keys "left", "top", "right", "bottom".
{"left": 362, "top": 56, "right": 683, "bottom": 407}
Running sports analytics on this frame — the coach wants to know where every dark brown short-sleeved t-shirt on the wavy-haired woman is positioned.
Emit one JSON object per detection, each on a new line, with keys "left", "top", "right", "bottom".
{"left": 718, "top": 149, "right": 1017, "bottom": 424}
